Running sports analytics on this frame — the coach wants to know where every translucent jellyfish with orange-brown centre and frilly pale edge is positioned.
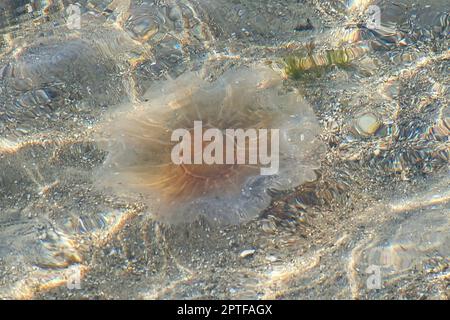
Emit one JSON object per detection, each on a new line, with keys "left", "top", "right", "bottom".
{"left": 95, "top": 67, "right": 321, "bottom": 224}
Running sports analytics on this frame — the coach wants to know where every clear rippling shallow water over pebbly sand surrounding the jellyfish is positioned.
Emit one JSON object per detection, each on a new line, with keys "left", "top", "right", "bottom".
{"left": 0, "top": 0, "right": 450, "bottom": 299}
